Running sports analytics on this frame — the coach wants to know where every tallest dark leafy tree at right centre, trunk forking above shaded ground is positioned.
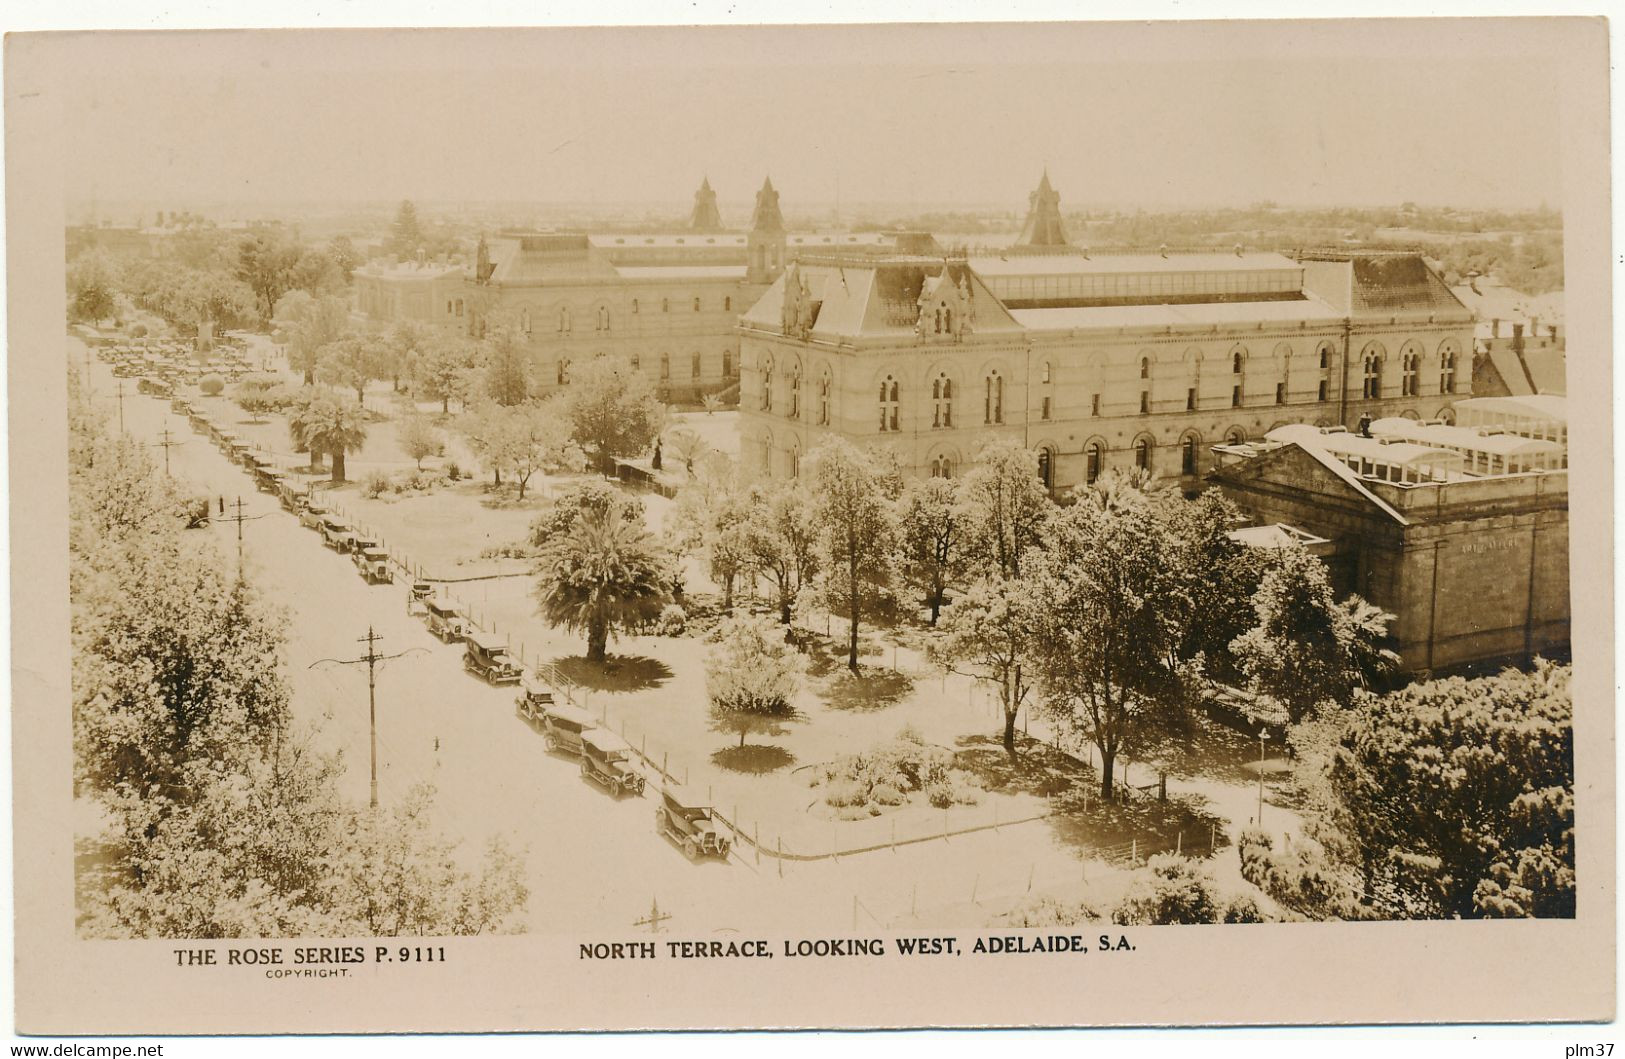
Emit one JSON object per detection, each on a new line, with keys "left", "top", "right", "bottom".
{"left": 1022, "top": 494, "right": 1194, "bottom": 797}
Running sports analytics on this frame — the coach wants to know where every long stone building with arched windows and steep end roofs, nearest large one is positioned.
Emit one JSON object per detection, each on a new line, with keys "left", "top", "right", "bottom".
{"left": 739, "top": 179, "right": 1472, "bottom": 492}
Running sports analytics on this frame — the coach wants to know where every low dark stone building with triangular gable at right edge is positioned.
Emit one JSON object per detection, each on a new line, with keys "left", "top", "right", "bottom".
{"left": 1212, "top": 403, "right": 1570, "bottom": 672}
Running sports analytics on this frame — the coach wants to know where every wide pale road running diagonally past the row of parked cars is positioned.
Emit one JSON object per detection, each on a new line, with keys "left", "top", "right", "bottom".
{"left": 79, "top": 339, "right": 1107, "bottom": 939}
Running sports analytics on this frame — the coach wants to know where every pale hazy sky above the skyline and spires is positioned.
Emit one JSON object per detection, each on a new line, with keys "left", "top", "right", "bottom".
{"left": 57, "top": 23, "right": 1562, "bottom": 211}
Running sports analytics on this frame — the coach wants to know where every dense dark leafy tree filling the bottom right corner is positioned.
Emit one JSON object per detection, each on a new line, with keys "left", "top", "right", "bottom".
{"left": 1321, "top": 661, "right": 1575, "bottom": 918}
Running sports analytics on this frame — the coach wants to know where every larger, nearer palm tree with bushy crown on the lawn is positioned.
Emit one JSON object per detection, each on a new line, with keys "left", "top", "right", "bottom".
{"left": 536, "top": 505, "right": 671, "bottom": 663}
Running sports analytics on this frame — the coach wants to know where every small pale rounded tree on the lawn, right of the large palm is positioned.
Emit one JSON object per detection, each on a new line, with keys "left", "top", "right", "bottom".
{"left": 705, "top": 614, "right": 803, "bottom": 747}
